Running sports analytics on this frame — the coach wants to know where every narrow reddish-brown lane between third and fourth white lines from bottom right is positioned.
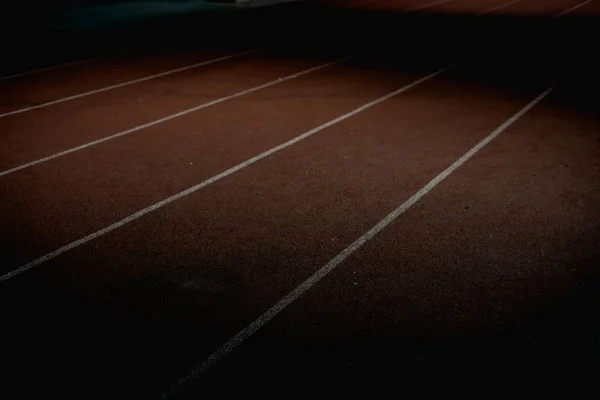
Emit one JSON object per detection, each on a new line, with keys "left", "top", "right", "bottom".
{"left": 0, "top": 49, "right": 336, "bottom": 170}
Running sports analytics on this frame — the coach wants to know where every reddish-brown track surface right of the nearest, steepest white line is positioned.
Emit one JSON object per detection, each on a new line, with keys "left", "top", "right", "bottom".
{"left": 192, "top": 89, "right": 600, "bottom": 390}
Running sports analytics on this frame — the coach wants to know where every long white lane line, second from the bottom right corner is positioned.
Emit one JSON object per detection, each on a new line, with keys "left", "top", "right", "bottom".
{"left": 0, "top": 64, "right": 453, "bottom": 282}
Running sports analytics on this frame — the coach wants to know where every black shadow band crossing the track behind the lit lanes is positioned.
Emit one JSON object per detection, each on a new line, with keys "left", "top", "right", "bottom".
{"left": 0, "top": 0, "right": 598, "bottom": 101}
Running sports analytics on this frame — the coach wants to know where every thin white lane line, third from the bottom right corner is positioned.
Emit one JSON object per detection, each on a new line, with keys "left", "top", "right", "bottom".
{"left": 0, "top": 57, "right": 352, "bottom": 177}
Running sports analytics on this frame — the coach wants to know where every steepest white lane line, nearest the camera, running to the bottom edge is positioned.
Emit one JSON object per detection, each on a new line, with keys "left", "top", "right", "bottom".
{"left": 163, "top": 87, "right": 553, "bottom": 398}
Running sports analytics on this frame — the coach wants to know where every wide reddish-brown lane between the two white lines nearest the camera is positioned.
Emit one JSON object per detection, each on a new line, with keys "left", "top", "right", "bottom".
{"left": 2, "top": 58, "right": 556, "bottom": 394}
